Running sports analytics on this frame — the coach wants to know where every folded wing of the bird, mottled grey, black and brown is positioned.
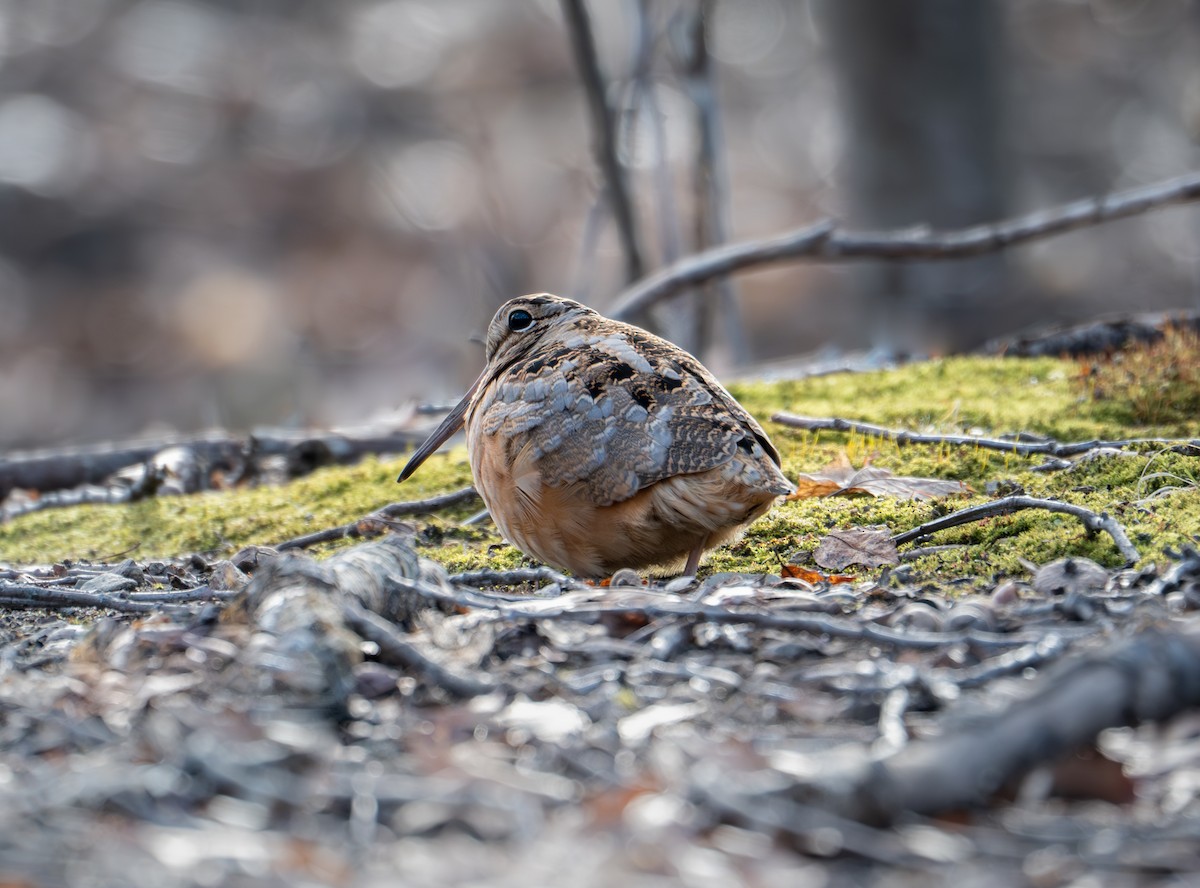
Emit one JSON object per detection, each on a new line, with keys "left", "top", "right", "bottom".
{"left": 481, "top": 325, "right": 788, "bottom": 505}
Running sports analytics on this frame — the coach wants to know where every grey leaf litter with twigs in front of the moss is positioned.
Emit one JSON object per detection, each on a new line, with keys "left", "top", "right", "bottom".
{"left": 0, "top": 534, "right": 1200, "bottom": 887}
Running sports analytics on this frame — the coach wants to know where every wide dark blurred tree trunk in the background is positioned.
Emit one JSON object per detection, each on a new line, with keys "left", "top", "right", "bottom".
{"left": 817, "top": 0, "right": 1009, "bottom": 353}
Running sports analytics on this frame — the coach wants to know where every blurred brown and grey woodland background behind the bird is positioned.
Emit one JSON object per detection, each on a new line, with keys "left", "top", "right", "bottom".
{"left": 0, "top": 0, "right": 1200, "bottom": 448}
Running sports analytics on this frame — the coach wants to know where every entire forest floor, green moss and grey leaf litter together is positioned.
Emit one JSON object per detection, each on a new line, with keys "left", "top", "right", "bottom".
{"left": 0, "top": 358, "right": 1200, "bottom": 887}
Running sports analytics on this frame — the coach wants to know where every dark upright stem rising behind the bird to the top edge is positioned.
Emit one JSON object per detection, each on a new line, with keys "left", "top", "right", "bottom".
{"left": 562, "top": 0, "right": 642, "bottom": 281}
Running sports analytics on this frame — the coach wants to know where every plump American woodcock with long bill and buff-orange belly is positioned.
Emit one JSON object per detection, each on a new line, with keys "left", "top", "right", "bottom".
{"left": 398, "top": 293, "right": 794, "bottom": 577}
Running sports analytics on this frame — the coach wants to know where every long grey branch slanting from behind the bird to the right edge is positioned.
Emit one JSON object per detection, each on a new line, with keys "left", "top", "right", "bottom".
{"left": 610, "top": 173, "right": 1200, "bottom": 319}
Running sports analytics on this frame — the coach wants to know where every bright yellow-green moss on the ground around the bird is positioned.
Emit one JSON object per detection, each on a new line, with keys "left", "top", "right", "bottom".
{"left": 0, "top": 358, "right": 1200, "bottom": 583}
